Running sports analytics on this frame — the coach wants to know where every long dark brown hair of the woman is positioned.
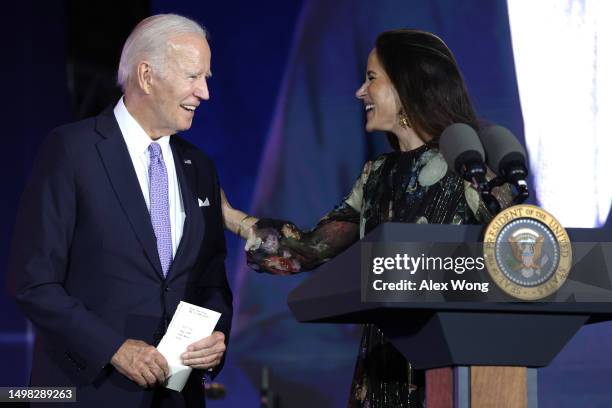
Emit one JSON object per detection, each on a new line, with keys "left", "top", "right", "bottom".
{"left": 376, "top": 29, "right": 478, "bottom": 150}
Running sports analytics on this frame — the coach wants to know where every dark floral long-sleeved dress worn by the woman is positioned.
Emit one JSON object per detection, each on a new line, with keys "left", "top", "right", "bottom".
{"left": 246, "top": 146, "right": 509, "bottom": 408}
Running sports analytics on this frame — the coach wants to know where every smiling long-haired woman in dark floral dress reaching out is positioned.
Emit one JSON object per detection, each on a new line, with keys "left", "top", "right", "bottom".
{"left": 223, "top": 29, "right": 509, "bottom": 408}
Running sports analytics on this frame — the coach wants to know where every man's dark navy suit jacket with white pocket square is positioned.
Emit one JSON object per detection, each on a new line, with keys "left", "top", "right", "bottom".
{"left": 8, "top": 108, "right": 232, "bottom": 407}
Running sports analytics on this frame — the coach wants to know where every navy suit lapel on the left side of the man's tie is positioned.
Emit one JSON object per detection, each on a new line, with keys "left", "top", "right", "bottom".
{"left": 96, "top": 108, "right": 163, "bottom": 277}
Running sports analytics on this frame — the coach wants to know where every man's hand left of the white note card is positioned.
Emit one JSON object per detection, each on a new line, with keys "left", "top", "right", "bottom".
{"left": 111, "top": 339, "right": 170, "bottom": 387}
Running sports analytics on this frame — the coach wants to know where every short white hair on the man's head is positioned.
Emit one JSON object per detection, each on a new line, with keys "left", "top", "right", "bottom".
{"left": 117, "top": 14, "right": 207, "bottom": 91}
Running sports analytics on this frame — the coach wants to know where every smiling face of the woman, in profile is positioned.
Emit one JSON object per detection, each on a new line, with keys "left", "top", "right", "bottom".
{"left": 355, "top": 49, "right": 401, "bottom": 133}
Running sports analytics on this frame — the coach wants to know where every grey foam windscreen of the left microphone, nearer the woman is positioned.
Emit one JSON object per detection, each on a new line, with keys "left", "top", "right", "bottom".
{"left": 440, "top": 123, "right": 485, "bottom": 175}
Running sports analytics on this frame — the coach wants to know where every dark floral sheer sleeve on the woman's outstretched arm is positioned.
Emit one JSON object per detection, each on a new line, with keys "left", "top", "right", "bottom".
{"left": 245, "top": 162, "right": 371, "bottom": 275}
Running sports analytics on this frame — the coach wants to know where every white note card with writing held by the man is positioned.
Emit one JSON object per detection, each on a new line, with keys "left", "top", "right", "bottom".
{"left": 157, "top": 302, "right": 221, "bottom": 392}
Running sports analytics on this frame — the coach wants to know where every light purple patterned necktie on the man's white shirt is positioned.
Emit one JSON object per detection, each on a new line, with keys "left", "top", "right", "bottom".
{"left": 149, "top": 142, "right": 172, "bottom": 277}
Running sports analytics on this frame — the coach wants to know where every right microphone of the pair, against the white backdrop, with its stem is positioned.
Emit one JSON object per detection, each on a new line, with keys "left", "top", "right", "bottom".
{"left": 480, "top": 125, "right": 529, "bottom": 204}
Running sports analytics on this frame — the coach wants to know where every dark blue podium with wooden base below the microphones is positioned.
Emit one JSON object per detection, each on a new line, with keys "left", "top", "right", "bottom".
{"left": 288, "top": 223, "right": 612, "bottom": 408}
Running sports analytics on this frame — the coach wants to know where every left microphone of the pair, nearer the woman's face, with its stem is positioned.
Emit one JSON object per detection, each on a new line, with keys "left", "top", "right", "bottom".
{"left": 440, "top": 123, "right": 501, "bottom": 215}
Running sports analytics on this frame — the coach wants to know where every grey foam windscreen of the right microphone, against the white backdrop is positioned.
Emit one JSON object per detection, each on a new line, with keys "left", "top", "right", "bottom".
{"left": 480, "top": 125, "right": 527, "bottom": 174}
